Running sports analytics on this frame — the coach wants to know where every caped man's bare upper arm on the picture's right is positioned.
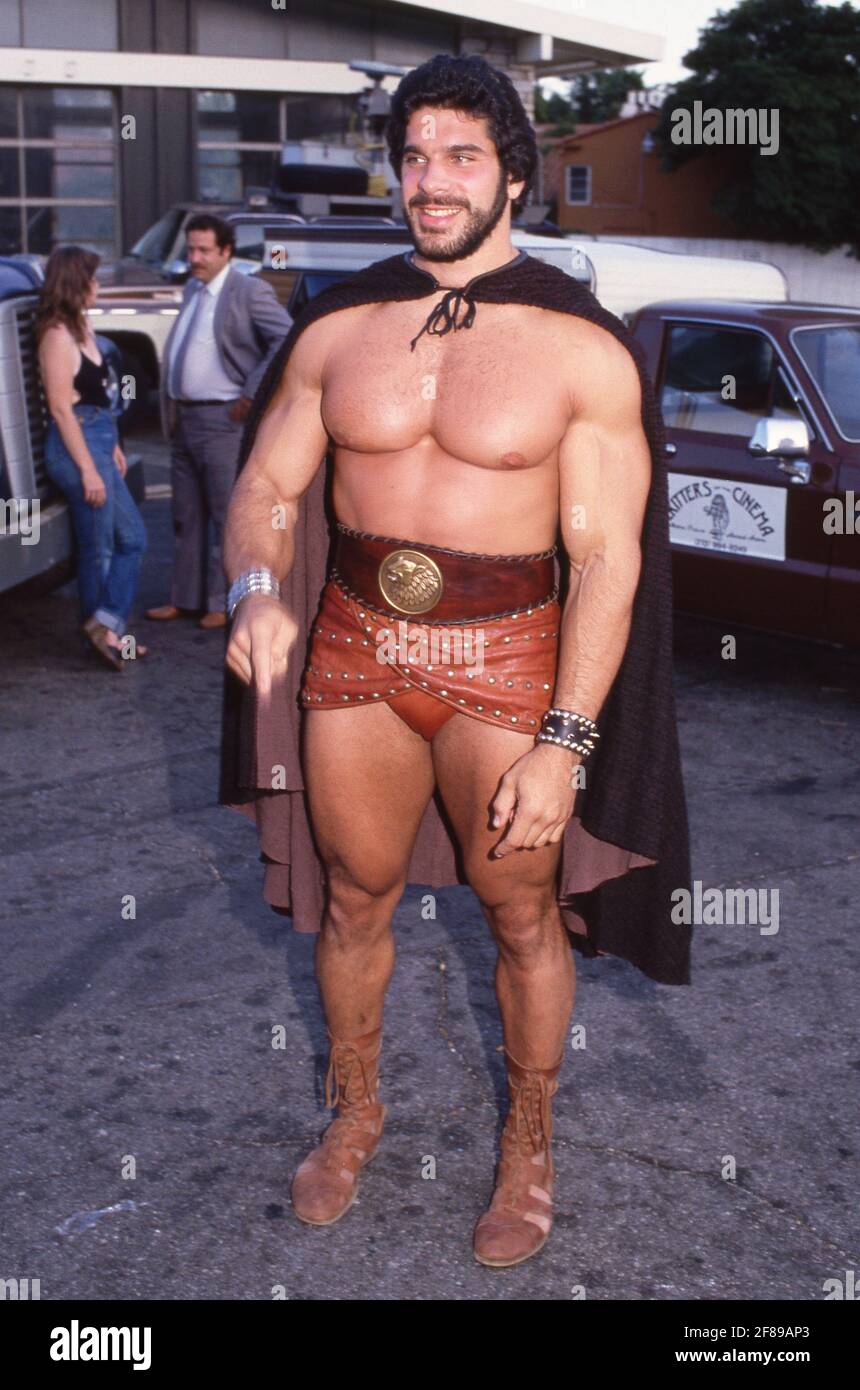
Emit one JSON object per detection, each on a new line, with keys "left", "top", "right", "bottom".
{"left": 559, "top": 335, "right": 652, "bottom": 567}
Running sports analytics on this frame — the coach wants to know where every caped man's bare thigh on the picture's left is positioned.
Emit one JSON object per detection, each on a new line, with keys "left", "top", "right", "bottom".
{"left": 301, "top": 702, "right": 433, "bottom": 894}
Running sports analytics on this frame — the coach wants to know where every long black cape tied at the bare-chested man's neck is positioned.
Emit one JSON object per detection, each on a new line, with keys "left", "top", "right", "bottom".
{"left": 218, "top": 253, "right": 692, "bottom": 984}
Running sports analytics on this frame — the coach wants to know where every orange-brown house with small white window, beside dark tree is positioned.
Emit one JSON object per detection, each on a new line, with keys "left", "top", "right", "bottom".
{"left": 557, "top": 111, "right": 739, "bottom": 236}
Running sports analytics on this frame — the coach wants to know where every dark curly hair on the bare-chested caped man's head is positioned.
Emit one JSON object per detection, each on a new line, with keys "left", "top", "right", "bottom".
{"left": 385, "top": 53, "right": 538, "bottom": 213}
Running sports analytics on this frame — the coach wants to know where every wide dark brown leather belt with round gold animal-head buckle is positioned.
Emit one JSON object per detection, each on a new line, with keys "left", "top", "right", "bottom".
{"left": 332, "top": 521, "right": 557, "bottom": 624}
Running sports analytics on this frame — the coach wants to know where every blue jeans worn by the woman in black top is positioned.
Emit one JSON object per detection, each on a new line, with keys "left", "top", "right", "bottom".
{"left": 44, "top": 404, "right": 146, "bottom": 637}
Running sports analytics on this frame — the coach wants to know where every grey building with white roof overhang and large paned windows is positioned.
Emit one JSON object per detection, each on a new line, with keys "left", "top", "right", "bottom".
{"left": 0, "top": 0, "right": 663, "bottom": 257}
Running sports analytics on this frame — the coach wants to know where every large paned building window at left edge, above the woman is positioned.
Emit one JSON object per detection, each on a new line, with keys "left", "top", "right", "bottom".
{"left": 0, "top": 86, "right": 119, "bottom": 257}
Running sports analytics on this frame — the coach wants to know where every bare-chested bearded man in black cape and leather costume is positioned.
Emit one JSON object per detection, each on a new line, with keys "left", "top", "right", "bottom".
{"left": 220, "top": 56, "right": 689, "bottom": 1266}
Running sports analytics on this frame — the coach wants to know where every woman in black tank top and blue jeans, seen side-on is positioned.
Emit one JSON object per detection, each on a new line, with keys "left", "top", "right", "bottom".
{"left": 36, "top": 246, "right": 147, "bottom": 671}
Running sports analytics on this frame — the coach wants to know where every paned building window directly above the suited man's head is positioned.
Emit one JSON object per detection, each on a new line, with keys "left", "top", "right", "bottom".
{"left": 196, "top": 92, "right": 286, "bottom": 203}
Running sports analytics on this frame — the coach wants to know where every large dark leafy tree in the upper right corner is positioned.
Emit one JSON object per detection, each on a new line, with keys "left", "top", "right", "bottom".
{"left": 654, "top": 0, "right": 860, "bottom": 254}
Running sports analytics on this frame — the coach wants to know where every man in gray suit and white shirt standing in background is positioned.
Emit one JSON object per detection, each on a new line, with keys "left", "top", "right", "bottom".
{"left": 146, "top": 213, "right": 292, "bottom": 628}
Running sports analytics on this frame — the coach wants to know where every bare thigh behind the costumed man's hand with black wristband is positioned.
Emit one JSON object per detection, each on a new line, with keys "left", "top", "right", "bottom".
{"left": 431, "top": 713, "right": 561, "bottom": 908}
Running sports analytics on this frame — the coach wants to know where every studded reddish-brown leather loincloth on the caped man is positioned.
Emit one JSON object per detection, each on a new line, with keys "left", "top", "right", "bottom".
{"left": 300, "top": 538, "right": 561, "bottom": 739}
